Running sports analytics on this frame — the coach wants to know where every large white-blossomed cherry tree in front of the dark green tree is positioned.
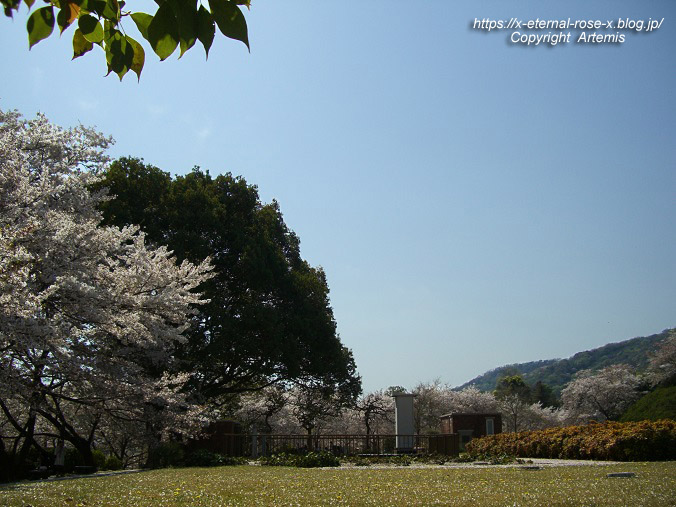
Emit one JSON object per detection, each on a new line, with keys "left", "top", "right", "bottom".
{"left": 0, "top": 111, "right": 211, "bottom": 478}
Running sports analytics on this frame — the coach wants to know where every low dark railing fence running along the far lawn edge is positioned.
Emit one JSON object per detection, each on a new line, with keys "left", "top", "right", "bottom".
{"left": 201, "top": 433, "right": 460, "bottom": 457}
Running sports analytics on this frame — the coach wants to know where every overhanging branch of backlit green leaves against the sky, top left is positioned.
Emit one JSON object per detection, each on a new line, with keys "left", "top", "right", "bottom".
{"left": 0, "top": 0, "right": 251, "bottom": 80}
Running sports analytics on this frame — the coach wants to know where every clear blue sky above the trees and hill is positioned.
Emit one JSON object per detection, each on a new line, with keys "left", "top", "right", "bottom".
{"left": 0, "top": 0, "right": 676, "bottom": 390}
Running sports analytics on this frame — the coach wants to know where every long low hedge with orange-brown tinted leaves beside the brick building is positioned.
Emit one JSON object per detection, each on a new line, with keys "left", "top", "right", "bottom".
{"left": 466, "top": 419, "right": 676, "bottom": 461}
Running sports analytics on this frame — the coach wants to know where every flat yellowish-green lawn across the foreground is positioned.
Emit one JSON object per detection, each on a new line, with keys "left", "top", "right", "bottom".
{"left": 0, "top": 462, "right": 676, "bottom": 507}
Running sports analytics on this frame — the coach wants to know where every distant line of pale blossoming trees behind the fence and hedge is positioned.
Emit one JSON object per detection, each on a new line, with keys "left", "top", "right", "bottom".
{"left": 235, "top": 331, "right": 676, "bottom": 435}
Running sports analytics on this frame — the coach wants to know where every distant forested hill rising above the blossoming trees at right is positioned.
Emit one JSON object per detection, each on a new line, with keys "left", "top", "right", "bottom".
{"left": 457, "top": 329, "right": 669, "bottom": 396}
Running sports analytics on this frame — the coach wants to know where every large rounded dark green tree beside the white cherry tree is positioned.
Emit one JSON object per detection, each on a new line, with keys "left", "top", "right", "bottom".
{"left": 94, "top": 158, "right": 360, "bottom": 400}
